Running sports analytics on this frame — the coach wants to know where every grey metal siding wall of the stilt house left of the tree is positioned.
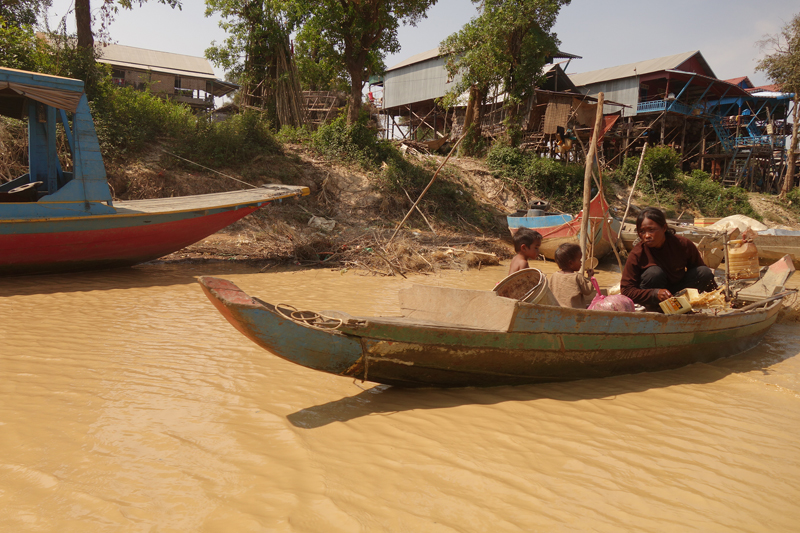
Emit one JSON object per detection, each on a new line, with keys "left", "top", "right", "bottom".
{"left": 383, "top": 57, "right": 460, "bottom": 107}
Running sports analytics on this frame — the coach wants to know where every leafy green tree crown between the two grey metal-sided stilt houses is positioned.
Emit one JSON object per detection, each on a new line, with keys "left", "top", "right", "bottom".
{"left": 439, "top": 0, "right": 570, "bottom": 141}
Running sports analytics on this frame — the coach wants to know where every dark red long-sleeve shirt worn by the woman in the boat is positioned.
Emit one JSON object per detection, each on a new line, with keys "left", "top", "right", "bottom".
{"left": 620, "top": 233, "right": 705, "bottom": 305}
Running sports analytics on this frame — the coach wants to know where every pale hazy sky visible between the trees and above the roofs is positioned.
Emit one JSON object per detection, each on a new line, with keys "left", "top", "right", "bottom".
{"left": 49, "top": 0, "right": 800, "bottom": 86}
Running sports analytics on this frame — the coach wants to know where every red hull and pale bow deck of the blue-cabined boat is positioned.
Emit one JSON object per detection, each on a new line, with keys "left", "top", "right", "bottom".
{"left": 0, "top": 186, "right": 308, "bottom": 275}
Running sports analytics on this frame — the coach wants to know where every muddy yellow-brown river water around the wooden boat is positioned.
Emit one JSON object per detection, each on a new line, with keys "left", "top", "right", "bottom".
{"left": 0, "top": 263, "right": 800, "bottom": 532}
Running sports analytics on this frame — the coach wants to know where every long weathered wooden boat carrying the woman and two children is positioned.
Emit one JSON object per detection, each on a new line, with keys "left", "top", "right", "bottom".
{"left": 199, "top": 270, "right": 781, "bottom": 387}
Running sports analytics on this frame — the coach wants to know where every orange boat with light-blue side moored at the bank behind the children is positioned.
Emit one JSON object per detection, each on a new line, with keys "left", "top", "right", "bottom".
{"left": 506, "top": 194, "right": 619, "bottom": 261}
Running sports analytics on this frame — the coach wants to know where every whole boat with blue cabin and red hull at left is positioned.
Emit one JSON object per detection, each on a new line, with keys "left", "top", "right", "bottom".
{"left": 0, "top": 68, "right": 308, "bottom": 274}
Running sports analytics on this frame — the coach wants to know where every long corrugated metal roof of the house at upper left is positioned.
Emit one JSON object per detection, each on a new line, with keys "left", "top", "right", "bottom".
{"left": 98, "top": 44, "right": 216, "bottom": 79}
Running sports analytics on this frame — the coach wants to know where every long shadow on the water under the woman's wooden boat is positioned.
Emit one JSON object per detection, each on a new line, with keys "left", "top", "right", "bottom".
{"left": 287, "top": 356, "right": 756, "bottom": 429}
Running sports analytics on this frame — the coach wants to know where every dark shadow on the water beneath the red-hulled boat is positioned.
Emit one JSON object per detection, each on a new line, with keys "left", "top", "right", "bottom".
{"left": 0, "top": 262, "right": 258, "bottom": 297}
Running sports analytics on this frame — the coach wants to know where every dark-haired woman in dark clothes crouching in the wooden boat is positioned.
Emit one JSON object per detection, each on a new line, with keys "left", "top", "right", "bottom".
{"left": 620, "top": 207, "right": 717, "bottom": 311}
